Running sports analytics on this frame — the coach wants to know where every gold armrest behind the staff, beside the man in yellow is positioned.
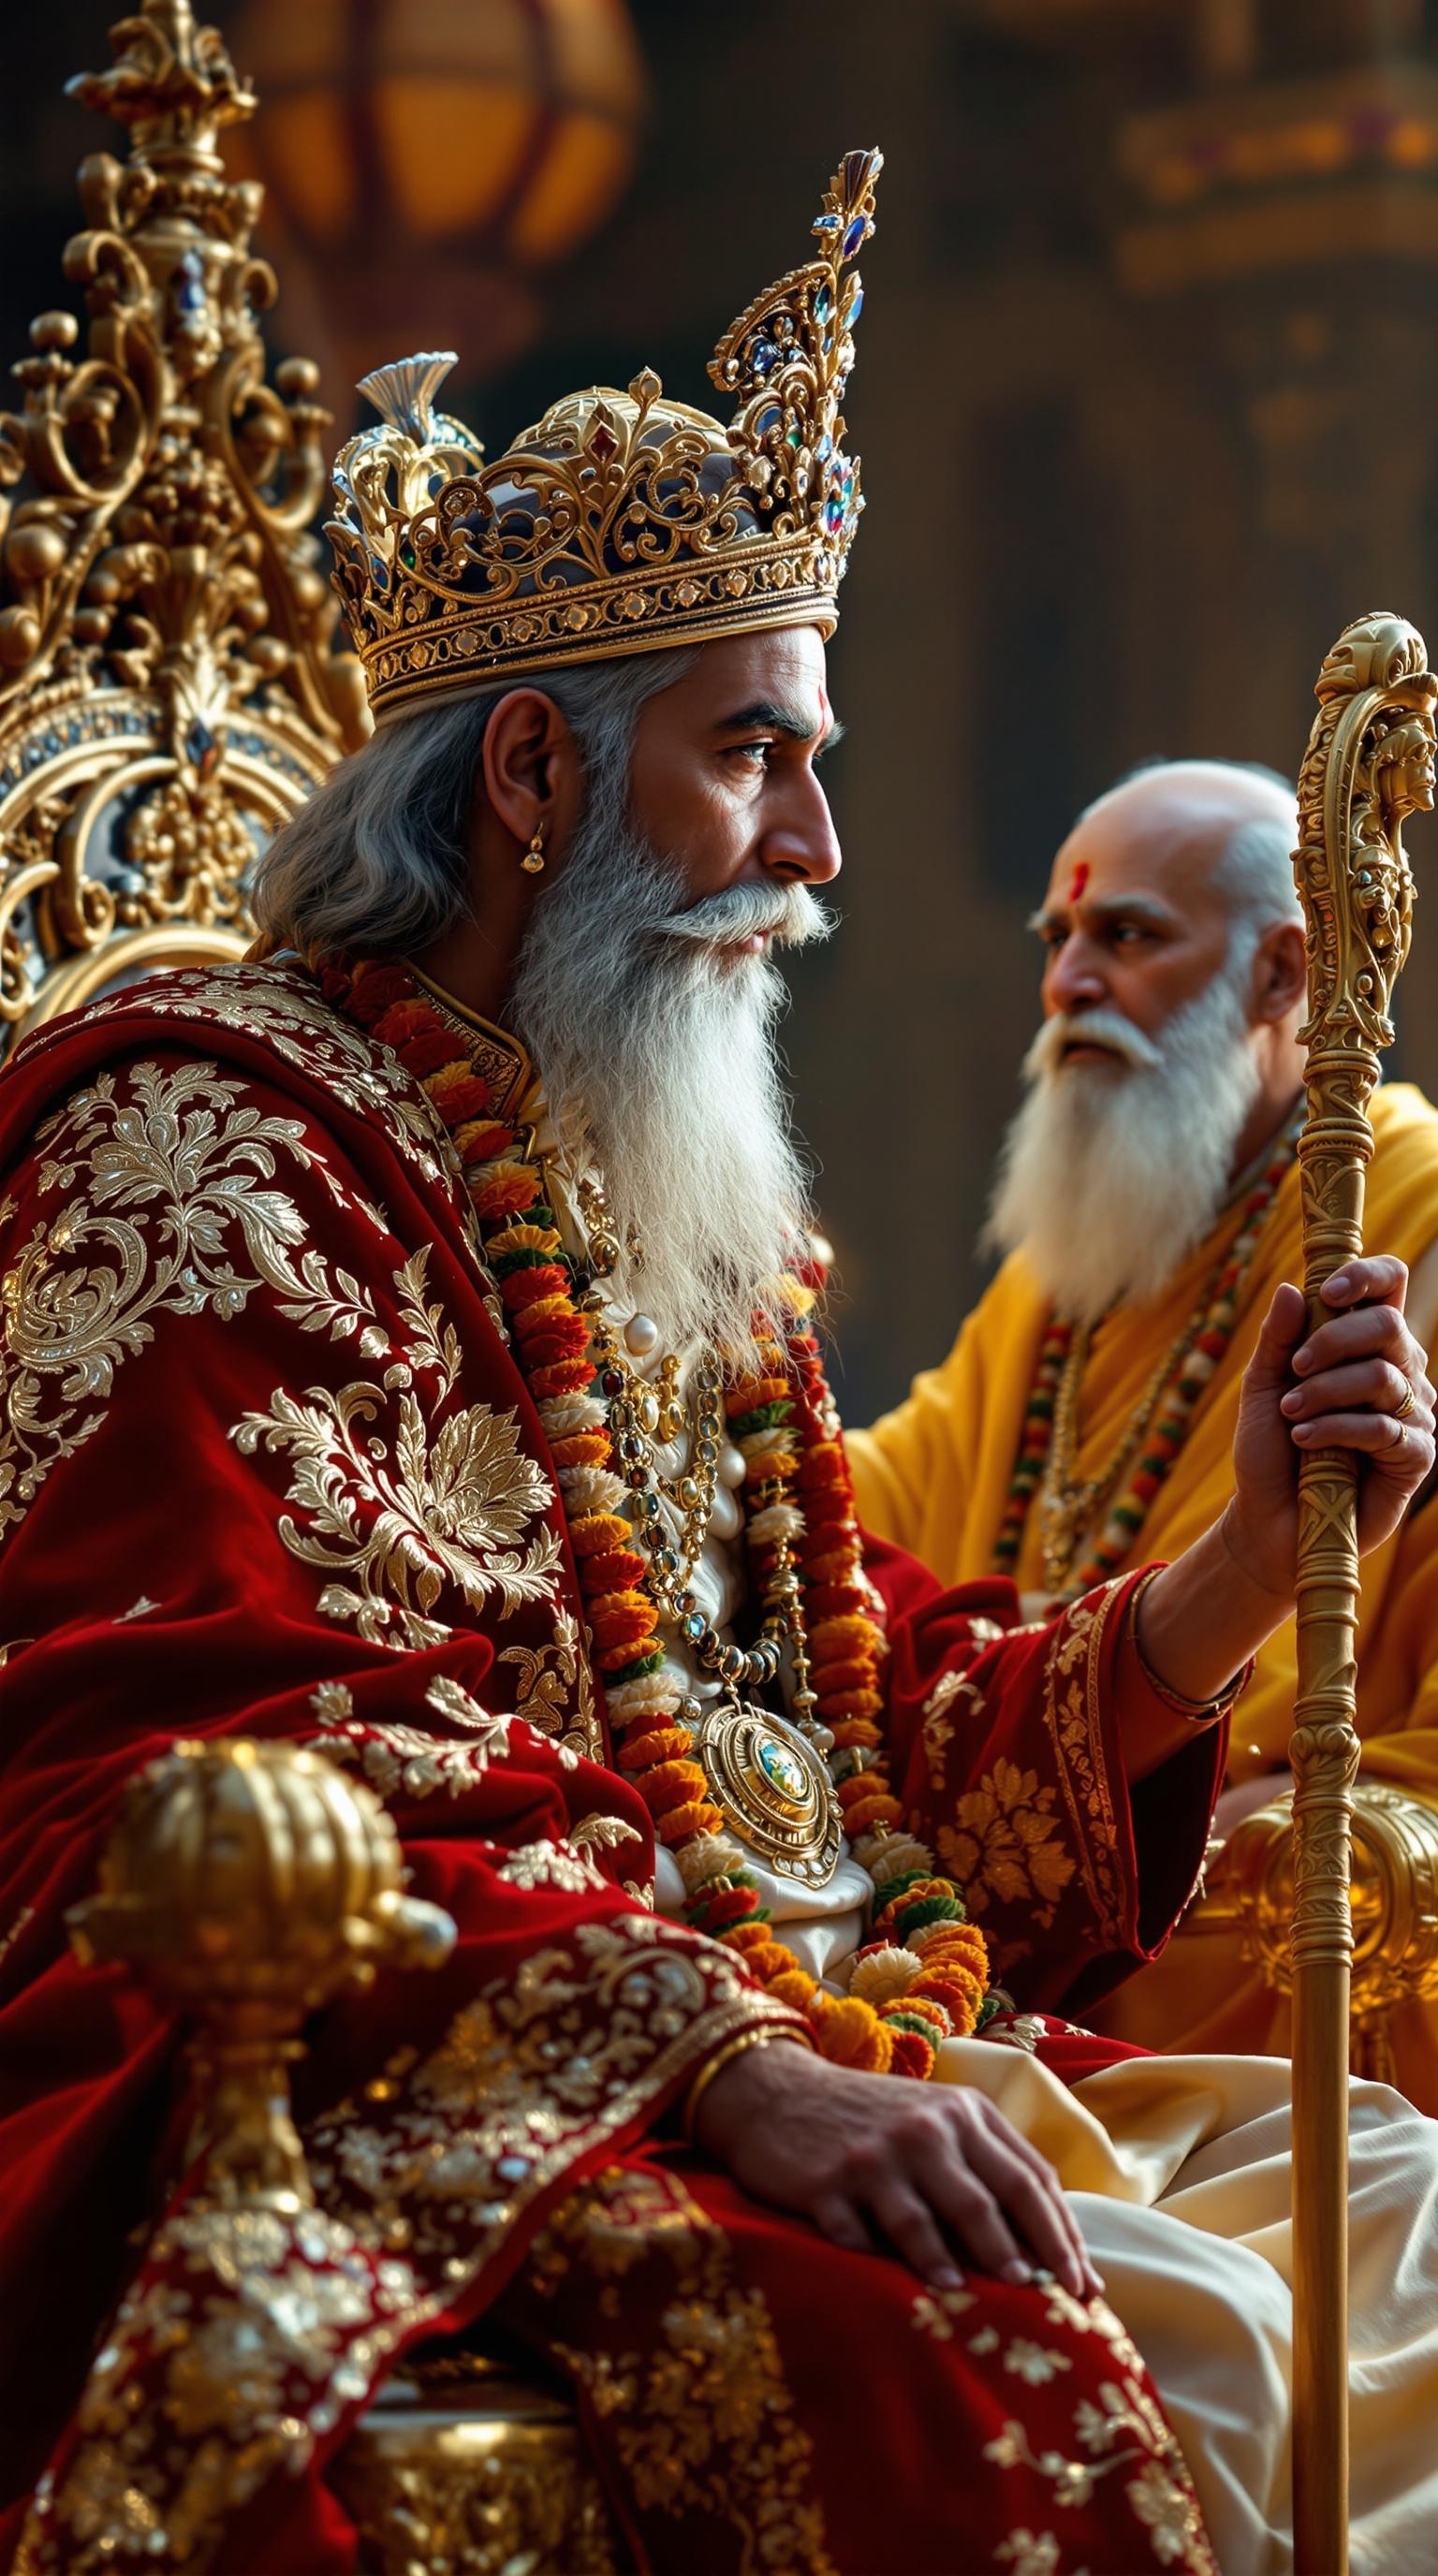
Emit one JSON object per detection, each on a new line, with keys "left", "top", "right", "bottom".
{"left": 1188, "top": 1780, "right": 1438, "bottom": 2084}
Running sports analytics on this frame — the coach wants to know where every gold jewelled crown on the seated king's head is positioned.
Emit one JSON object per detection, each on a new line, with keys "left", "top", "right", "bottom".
{"left": 328, "top": 152, "right": 884, "bottom": 722}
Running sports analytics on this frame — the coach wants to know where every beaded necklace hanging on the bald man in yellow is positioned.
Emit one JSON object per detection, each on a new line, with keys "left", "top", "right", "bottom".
{"left": 992, "top": 1110, "right": 1301, "bottom": 1600}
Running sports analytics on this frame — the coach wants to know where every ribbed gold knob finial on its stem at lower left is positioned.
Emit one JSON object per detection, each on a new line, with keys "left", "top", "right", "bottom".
{"left": 69, "top": 1739, "right": 453, "bottom": 2207}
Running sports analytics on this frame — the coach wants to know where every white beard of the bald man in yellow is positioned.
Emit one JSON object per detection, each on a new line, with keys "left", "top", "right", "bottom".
{"left": 985, "top": 953, "right": 1260, "bottom": 1325}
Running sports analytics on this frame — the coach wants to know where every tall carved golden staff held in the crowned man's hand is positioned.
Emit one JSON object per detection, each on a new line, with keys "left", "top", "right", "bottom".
{"left": 1288, "top": 613, "right": 1438, "bottom": 2576}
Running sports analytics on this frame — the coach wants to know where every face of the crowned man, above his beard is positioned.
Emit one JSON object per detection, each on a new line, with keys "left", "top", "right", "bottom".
{"left": 631, "top": 626, "right": 840, "bottom": 950}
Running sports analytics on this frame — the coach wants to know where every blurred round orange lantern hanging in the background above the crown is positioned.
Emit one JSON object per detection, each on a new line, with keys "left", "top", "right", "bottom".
{"left": 232, "top": 0, "right": 644, "bottom": 373}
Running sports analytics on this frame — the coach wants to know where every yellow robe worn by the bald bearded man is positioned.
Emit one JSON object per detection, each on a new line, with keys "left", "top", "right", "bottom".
{"left": 848, "top": 1082, "right": 1438, "bottom": 2113}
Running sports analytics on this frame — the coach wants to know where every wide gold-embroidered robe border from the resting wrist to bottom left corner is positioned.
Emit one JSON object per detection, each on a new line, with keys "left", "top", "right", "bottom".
{"left": 18, "top": 1916, "right": 804, "bottom": 2576}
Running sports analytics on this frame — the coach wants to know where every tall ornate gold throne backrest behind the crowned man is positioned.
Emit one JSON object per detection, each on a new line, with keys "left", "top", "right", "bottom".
{"left": 0, "top": 0, "right": 369, "bottom": 1054}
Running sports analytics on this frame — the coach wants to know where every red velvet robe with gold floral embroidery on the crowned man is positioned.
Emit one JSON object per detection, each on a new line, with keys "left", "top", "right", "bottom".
{"left": 0, "top": 966, "right": 1225, "bottom": 2576}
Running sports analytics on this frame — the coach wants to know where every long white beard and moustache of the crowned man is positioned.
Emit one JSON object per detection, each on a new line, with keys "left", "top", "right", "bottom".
{"left": 513, "top": 783, "right": 832, "bottom": 1363}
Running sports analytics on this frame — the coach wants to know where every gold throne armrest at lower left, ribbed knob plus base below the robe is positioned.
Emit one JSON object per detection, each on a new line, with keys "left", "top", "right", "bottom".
{"left": 69, "top": 1741, "right": 629, "bottom": 2576}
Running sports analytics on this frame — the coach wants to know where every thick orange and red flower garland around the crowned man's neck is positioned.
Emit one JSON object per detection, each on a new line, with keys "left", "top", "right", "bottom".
{"left": 319, "top": 959, "right": 997, "bottom": 2076}
